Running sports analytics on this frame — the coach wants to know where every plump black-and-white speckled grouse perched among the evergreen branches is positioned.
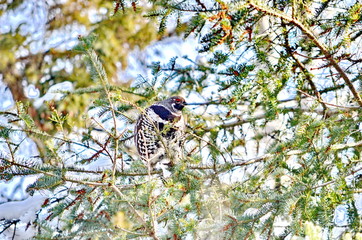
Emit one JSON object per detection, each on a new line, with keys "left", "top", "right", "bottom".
{"left": 134, "top": 96, "right": 187, "bottom": 177}
